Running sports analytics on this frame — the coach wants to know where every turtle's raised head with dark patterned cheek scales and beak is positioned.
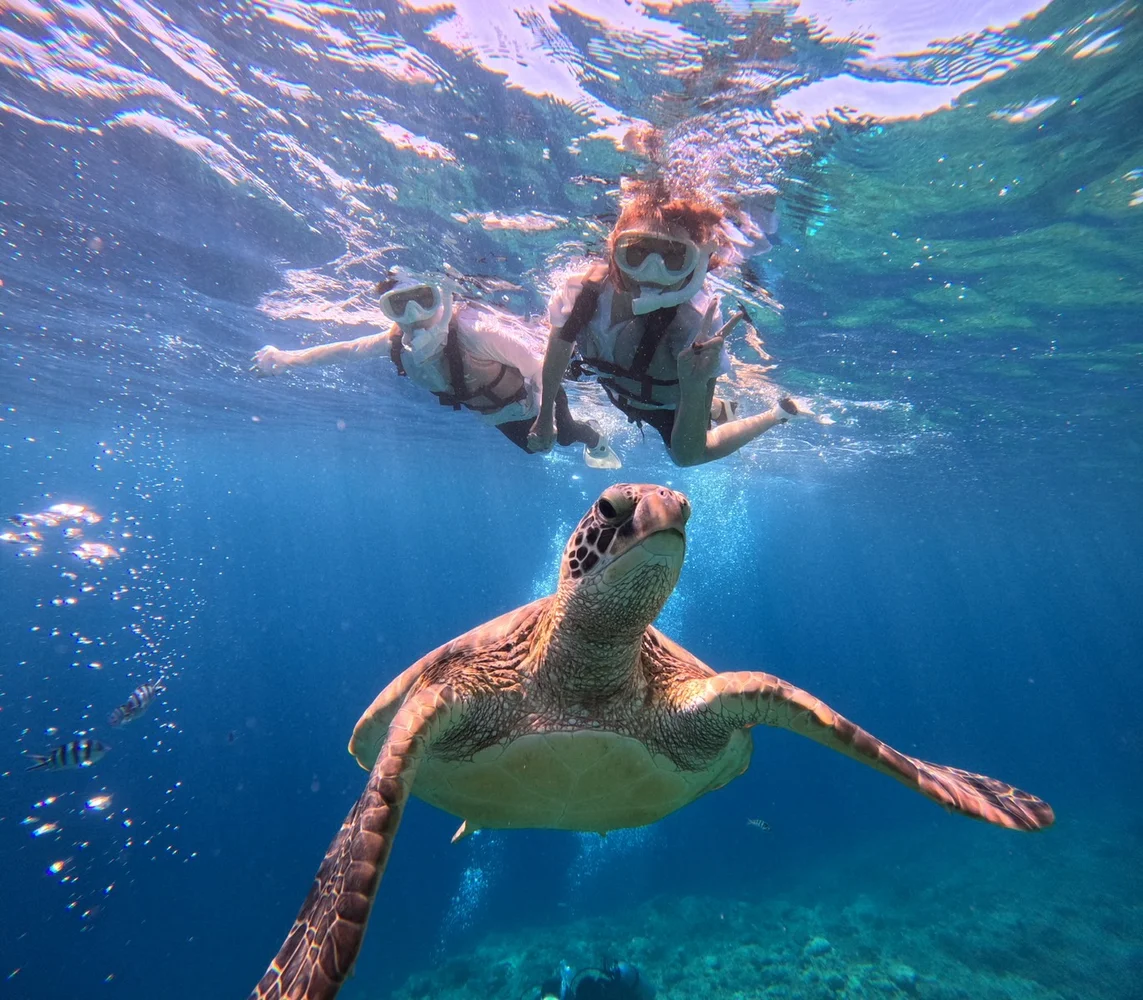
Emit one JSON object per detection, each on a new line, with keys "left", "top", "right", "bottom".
{"left": 558, "top": 483, "right": 690, "bottom": 637}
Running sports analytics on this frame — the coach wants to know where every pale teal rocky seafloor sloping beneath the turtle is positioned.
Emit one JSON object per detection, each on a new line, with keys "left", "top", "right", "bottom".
{"left": 390, "top": 819, "right": 1143, "bottom": 1000}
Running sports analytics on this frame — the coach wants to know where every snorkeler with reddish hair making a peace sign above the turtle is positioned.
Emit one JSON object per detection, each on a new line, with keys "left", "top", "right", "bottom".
{"left": 529, "top": 181, "right": 808, "bottom": 465}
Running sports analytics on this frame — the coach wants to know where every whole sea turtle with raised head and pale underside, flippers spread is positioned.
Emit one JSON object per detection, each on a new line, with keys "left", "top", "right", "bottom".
{"left": 250, "top": 485, "right": 1055, "bottom": 1000}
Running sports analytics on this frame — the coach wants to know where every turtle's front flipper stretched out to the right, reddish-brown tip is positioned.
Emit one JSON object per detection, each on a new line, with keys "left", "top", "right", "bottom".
{"left": 680, "top": 672, "right": 1055, "bottom": 830}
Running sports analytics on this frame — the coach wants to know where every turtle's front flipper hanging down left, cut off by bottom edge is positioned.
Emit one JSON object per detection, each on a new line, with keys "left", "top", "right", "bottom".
{"left": 248, "top": 687, "right": 454, "bottom": 1000}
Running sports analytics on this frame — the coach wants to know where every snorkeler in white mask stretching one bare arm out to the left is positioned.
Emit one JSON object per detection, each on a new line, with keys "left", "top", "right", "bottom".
{"left": 253, "top": 267, "right": 622, "bottom": 469}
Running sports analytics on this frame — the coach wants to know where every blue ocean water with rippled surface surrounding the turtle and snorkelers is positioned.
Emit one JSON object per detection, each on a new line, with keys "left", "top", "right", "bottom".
{"left": 0, "top": 0, "right": 1143, "bottom": 1000}
